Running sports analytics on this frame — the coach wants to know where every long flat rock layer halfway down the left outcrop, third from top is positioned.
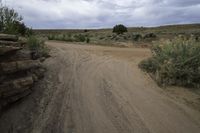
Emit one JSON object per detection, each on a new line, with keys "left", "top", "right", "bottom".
{"left": 0, "top": 60, "right": 41, "bottom": 74}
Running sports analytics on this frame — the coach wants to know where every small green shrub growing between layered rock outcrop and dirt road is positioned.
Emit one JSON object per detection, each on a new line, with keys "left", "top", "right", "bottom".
{"left": 27, "top": 36, "right": 49, "bottom": 59}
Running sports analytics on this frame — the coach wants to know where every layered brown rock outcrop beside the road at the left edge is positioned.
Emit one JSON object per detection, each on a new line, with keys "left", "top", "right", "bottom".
{"left": 0, "top": 34, "right": 45, "bottom": 111}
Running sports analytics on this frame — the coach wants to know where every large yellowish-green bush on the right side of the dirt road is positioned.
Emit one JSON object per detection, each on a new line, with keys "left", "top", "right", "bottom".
{"left": 139, "top": 38, "right": 200, "bottom": 88}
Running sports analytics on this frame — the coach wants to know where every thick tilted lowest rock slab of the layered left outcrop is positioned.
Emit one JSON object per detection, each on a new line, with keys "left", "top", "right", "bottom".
{"left": 0, "top": 76, "right": 34, "bottom": 98}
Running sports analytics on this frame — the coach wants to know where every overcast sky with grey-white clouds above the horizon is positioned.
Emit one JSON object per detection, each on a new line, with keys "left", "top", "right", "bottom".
{"left": 3, "top": 0, "right": 200, "bottom": 28}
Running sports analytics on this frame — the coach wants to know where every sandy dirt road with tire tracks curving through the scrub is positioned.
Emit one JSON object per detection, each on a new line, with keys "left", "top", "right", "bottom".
{"left": 0, "top": 42, "right": 200, "bottom": 133}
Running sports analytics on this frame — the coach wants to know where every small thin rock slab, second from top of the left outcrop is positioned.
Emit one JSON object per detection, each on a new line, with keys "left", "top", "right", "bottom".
{"left": 0, "top": 46, "right": 22, "bottom": 55}
